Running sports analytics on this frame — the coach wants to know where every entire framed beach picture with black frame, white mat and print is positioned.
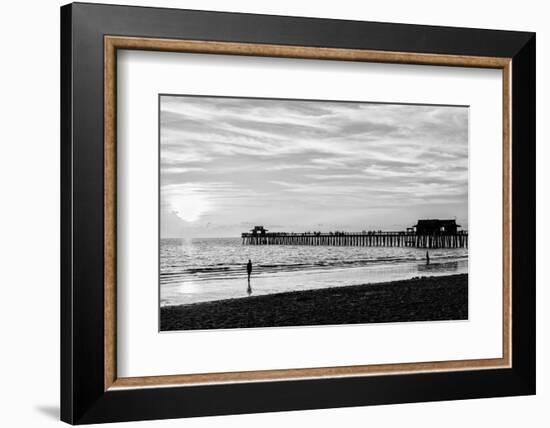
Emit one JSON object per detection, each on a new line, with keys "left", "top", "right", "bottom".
{"left": 61, "top": 3, "right": 535, "bottom": 424}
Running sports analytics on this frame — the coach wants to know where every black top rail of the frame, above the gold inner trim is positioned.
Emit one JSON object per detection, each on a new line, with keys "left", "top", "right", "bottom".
{"left": 72, "top": 2, "right": 532, "bottom": 57}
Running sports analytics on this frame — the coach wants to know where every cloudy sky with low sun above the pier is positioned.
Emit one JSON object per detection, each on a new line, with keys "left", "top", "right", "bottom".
{"left": 160, "top": 95, "right": 468, "bottom": 237}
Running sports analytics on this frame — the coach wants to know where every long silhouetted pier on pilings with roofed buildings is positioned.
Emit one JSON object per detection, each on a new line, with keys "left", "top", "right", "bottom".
{"left": 242, "top": 220, "right": 468, "bottom": 248}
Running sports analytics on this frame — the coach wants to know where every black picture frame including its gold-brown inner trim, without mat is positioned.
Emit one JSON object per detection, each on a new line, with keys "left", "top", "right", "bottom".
{"left": 61, "top": 3, "right": 536, "bottom": 424}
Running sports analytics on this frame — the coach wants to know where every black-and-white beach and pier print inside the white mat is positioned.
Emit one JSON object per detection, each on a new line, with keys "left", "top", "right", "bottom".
{"left": 159, "top": 94, "right": 469, "bottom": 331}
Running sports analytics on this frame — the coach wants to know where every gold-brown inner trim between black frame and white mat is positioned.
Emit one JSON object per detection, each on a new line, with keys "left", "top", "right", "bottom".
{"left": 104, "top": 36, "right": 512, "bottom": 391}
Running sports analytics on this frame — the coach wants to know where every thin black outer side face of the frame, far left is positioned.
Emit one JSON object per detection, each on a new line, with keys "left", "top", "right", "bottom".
{"left": 60, "top": 5, "right": 74, "bottom": 423}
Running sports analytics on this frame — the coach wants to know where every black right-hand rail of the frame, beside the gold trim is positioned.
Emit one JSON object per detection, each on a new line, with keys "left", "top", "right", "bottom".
{"left": 512, "top": 33, "right": 536, "bottom": 394}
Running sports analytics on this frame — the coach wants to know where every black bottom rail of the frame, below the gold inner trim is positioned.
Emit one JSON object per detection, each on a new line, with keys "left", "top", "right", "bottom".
{"left": 78, "top": 370, "right": 533, "bottom": 424}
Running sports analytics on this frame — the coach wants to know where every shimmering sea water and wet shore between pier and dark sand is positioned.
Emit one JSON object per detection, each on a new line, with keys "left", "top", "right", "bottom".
{"left": 160, "top": 238, "right": 468, "bottom": 306}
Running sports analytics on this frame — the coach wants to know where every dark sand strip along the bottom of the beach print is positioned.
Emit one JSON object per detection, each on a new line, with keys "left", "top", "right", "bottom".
{"left": 160, "top": 274, "right": 468, "bottom": 331}
